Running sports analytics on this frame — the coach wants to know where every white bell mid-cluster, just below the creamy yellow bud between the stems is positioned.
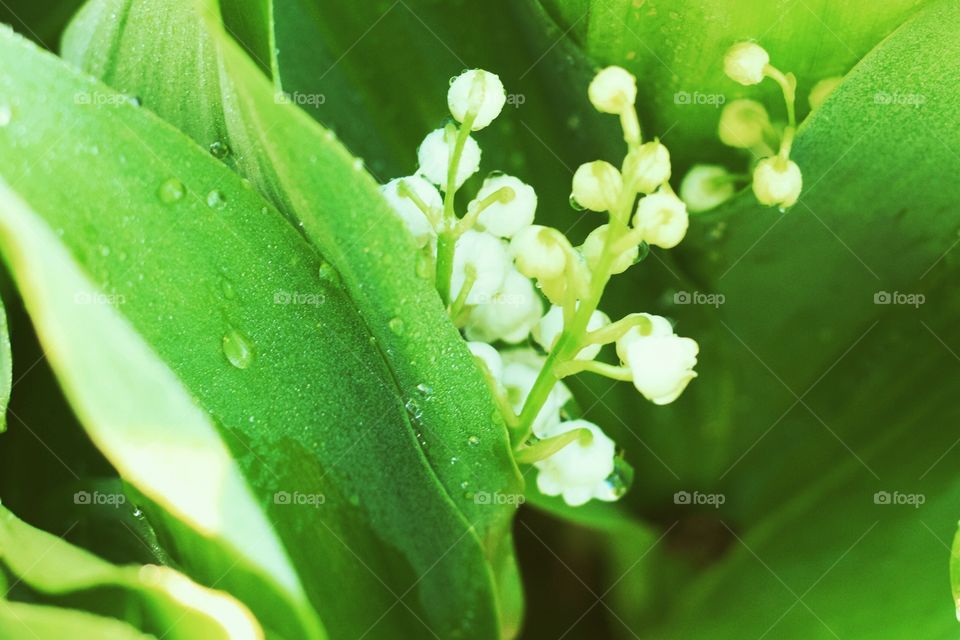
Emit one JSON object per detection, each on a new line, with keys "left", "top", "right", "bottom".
{"left": 464, "top": 269, "right": 543, "bottom": 344}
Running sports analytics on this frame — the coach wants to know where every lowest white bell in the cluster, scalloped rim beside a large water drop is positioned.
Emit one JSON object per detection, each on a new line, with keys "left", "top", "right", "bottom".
{"left": 534, "top": 420, "right": 616, "bottom": 507}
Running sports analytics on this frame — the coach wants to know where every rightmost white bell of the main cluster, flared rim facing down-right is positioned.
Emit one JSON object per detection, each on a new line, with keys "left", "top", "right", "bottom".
{"left": 617, "top": 316, "right": 700, "bottom": 405}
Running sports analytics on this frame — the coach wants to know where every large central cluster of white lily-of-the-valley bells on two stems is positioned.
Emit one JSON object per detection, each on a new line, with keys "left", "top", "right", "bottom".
{"left": 382, "top": 67, "right": 698, "bottom": 505}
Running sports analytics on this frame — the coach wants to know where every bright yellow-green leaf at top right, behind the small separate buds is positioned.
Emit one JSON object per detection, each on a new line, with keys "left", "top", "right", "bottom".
{"left": 540, "top": 0, "right": 929, "bottom": 156}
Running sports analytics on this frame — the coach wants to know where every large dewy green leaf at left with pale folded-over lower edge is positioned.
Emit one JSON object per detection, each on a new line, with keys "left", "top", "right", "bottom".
{"left": 0, "top": 27, "right": 515, "bottom": 637}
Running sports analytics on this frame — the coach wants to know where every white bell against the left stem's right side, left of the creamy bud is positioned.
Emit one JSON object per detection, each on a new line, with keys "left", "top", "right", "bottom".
{"left": 450, "top": 231, "right": 510, "bottom": 305}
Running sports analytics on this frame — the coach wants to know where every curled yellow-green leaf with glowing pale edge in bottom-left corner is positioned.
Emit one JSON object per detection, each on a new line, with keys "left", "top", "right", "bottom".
{"left": 0, "top": 507, "right": 263, "bottom": 640}
